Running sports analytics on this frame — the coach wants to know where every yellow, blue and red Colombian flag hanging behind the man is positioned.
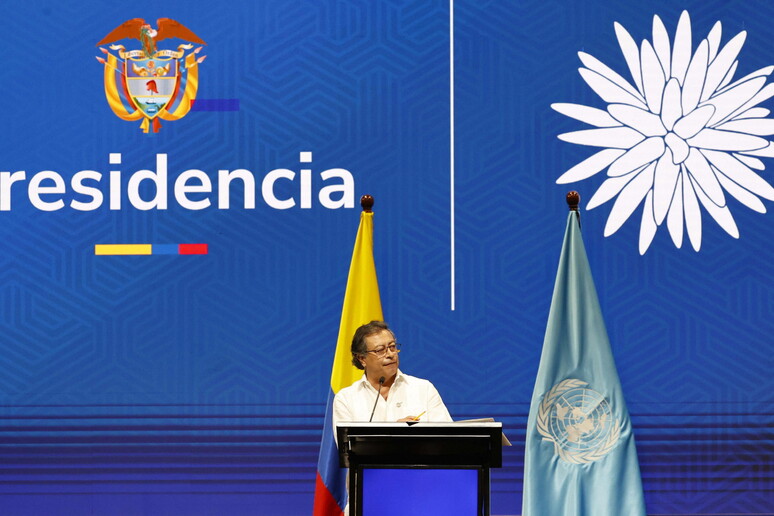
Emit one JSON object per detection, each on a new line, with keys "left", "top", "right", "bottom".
{"left": 312, "top": 207, "right": 383, "bottom": 516}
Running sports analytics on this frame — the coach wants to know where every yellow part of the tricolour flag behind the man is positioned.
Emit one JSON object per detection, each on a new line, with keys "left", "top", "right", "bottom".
{"left": 331, "top": 211, "right": 384, "bottom": 394}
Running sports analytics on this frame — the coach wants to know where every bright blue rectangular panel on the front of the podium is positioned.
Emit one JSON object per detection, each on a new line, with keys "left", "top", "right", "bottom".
{"left": 363, "top": 469, "right": 478, "bottom": 516}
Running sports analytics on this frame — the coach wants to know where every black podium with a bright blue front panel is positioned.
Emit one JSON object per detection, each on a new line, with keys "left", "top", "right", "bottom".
{"left": 336, "top": 422, "right": 502, "bottom": 516}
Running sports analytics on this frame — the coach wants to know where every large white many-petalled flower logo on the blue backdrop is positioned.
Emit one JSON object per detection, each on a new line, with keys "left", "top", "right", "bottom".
{"left": 551, "top": 11, "right": 774, "bottom": 254}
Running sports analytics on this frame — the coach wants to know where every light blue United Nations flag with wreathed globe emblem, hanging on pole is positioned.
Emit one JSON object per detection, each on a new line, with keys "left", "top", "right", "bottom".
{"left": 522, "top": 212, "right": 645, "bottom": 516}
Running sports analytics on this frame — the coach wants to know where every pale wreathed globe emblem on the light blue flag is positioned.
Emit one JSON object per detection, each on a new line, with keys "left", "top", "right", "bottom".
{"left": 537, "top": 378, "right": 621, "bottom": 464}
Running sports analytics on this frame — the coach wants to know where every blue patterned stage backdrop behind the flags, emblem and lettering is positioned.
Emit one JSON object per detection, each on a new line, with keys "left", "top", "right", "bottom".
{"left": 0, "top": 0, "right": 774, "bottom": 516}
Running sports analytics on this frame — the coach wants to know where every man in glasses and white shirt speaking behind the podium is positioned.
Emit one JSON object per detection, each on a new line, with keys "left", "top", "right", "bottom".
{"left": 333, "top": 321, "right": 452, "bottom": 428}
